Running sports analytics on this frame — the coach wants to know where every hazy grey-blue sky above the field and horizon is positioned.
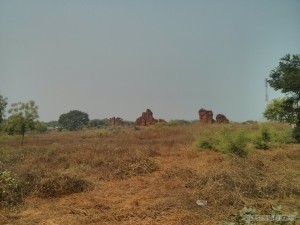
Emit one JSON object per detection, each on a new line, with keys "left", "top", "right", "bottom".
{"left": 0, "top": 0, "right": 300, "bottom": 122}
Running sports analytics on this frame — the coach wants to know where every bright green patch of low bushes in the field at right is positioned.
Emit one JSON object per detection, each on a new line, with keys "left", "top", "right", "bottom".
{"left": 193, "top": 123, "right": 295, "bottom": 157}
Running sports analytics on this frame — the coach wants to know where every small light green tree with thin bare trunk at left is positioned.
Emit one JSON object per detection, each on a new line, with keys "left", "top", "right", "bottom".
{"left": 4, "top": 101, "right": 39, "bottom": 145}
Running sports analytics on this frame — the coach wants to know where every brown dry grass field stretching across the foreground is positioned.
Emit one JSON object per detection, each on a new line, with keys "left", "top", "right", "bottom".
{"left": 0, "top": 124, "right": 300, "bottom": 225}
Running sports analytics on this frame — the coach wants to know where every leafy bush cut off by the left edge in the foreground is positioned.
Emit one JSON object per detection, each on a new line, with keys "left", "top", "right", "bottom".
{"left": 0, "top": 170, "right": 23, "bottom": 207}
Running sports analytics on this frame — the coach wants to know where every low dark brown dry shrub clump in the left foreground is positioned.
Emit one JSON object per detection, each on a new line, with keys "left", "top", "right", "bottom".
{"left": 37, "top": 175, "right": 92, "bottom": 198}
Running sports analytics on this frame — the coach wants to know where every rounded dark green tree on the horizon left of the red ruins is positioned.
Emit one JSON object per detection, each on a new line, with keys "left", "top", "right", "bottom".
{"left": 58, "top": 110, "right": 89, "bottom": 130}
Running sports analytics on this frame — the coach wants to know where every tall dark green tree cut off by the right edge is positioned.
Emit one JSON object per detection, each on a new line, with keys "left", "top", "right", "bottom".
{"left": 268, "top": 54, "right": 300, "bottom": 142}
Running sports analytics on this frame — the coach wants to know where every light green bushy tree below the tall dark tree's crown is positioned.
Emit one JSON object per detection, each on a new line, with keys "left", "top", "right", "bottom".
{"left": 263, "top": 97, "right": 296, "bottom": 124}
